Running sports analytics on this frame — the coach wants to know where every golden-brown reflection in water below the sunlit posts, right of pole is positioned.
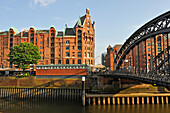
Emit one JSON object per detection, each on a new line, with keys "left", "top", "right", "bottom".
{"left": 86, "top": 104, "right": 170, "bottom": 113}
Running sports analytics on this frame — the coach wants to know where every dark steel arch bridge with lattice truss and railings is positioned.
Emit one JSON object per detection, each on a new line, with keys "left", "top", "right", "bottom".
{"left": 111, "top": 11, "right": 170, "bottom": 87}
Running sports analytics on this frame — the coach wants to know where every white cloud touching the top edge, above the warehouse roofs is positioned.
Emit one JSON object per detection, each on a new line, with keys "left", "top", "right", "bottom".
{"left": 30, "top": 0, "right": 57, "bottom": 8}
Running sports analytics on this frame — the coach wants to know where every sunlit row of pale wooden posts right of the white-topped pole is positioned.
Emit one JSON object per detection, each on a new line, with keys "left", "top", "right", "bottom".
{"left": 86, "top": 95, "right": 170, "bottom": 105}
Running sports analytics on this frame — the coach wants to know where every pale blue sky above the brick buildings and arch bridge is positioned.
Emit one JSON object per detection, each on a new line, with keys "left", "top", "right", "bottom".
{"left": 0, "top": 0, "right": 170, "bottom": 64}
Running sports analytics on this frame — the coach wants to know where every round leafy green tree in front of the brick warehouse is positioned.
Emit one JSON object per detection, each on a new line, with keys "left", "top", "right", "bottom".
{"left": 8, "top": 42, "right": 41, "bottom": 71}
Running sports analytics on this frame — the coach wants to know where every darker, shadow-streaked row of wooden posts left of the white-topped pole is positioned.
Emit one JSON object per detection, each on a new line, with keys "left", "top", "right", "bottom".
{"left": 0, "top": 88, "right": 90, "bottom": 101}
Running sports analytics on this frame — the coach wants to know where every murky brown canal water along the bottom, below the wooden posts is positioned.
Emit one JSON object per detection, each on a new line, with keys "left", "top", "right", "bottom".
{"left": 0, "top": 100, "right": 170, "bottom": 113}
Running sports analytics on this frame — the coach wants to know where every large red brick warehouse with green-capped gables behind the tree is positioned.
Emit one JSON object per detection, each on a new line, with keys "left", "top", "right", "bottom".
{"left": 0, "top": 9, "right": 95, "bottom": 68}
